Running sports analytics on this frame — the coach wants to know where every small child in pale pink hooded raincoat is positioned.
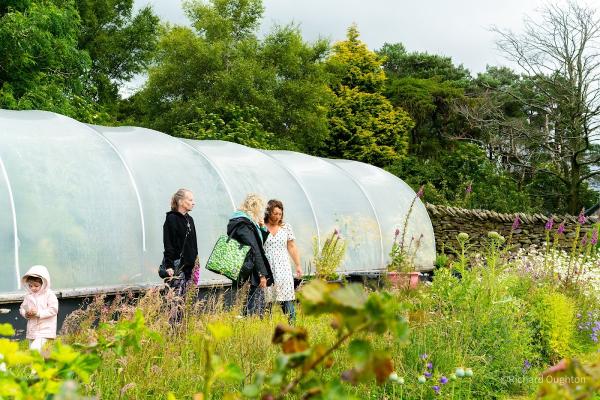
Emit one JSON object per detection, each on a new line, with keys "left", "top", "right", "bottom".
{"left": 19, "top": 265, "right": 58, "bottom": 351}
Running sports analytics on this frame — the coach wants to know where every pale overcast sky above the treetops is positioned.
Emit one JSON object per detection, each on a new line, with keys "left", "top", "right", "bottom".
{"left": 135, "top": 0, "right": 580, "bottom": 74}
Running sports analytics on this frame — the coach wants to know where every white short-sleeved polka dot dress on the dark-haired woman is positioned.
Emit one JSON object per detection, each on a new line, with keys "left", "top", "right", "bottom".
{"left": 265, "top": 224, "right": 296, "bottom": 301}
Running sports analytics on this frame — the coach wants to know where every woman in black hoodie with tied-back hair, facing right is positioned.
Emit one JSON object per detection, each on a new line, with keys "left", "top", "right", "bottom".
{"left": 161, "top": 189, "right": 198, "bottom": 295}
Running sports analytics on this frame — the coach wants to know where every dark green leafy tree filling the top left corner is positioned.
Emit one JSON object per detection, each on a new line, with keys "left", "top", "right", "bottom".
{"left": 0, "top": 0, "right": 99, "bottom": 121}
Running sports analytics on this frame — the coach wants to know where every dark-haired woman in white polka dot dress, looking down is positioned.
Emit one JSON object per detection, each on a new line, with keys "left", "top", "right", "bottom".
{"left": 264, "top": 200, "right": 302, "bottom": 324}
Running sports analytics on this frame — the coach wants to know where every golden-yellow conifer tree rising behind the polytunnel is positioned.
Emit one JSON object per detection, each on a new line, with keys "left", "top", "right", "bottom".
{"left": 325, "top": 26, "right": 414, "bottom": 166}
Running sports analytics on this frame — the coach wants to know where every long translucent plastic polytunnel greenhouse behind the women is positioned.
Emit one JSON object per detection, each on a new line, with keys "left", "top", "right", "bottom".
{"left": 0, "top": 110, "right": 435, "bottom": 295}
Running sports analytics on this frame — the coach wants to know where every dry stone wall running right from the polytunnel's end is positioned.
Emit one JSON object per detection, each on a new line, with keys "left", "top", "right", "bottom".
{"left": 425, "top": 203, "right": 598, "bottom": 253}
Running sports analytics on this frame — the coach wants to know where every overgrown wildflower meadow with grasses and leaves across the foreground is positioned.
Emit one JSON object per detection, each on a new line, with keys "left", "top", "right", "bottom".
{"left": 0, "top": 208, "right": 600, "bottom": 399}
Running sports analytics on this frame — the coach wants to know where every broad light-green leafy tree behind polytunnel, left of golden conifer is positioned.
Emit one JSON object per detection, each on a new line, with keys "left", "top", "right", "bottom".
{"left": 129, "top": 0, "right": 330, "bottom": 151}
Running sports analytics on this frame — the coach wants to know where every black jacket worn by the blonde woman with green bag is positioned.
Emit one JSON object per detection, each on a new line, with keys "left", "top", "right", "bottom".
{"left": 227, "top": 217, "right": 273, "bottom": 286}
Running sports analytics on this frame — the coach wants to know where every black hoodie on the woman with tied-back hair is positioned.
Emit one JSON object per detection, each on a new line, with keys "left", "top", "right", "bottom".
{"left": 163, "top": 211, "right": 198, "bottom": 279}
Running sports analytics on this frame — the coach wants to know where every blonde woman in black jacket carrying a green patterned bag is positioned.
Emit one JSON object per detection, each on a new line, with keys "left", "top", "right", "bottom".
{"left": 227, "top": 194, "right": 273, "bottom": 318}
